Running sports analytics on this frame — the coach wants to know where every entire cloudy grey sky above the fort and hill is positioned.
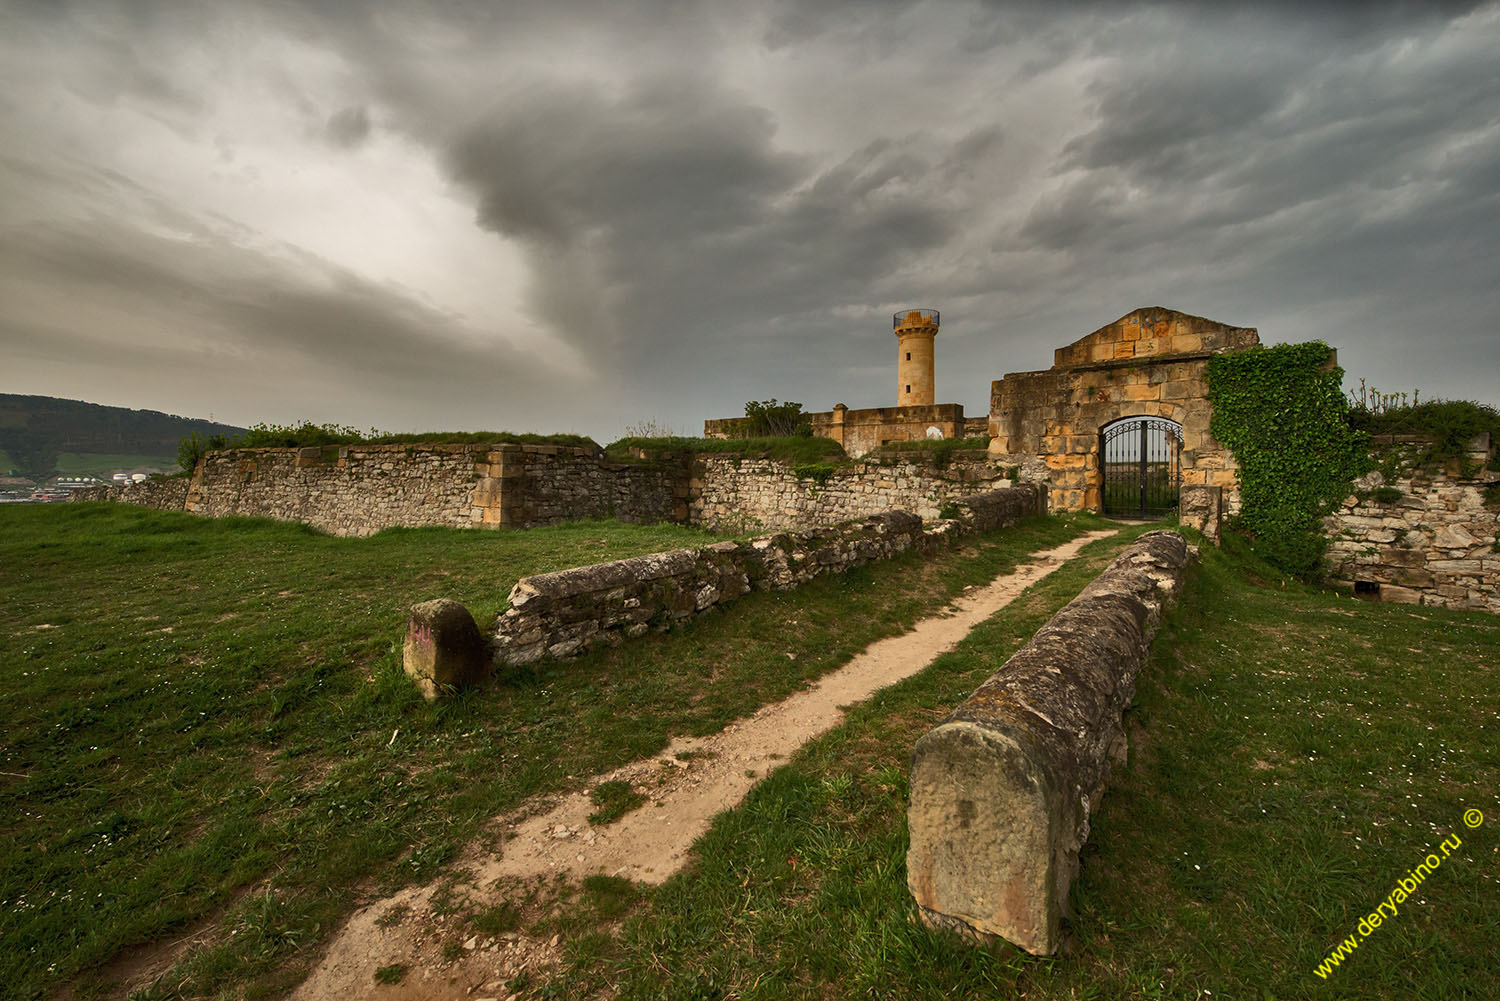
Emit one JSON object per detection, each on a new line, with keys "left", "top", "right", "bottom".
{"left": 0, "top": 0, "right": 1500, "bottom": 441}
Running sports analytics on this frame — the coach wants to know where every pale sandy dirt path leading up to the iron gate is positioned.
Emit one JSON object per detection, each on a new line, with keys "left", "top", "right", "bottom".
{"left": 293, "top": 530, "right": 1115, "bottom": 1001}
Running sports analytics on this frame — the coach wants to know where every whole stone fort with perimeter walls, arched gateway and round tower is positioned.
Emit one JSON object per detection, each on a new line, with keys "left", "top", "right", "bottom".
{"left": 75, "top": 306, "right": 1500, "bottom": 611}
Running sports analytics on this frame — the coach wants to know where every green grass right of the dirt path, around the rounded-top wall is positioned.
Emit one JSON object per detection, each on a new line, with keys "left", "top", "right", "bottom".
{"left": 542, "top": 528, "right": 1500, "bottom": 1001}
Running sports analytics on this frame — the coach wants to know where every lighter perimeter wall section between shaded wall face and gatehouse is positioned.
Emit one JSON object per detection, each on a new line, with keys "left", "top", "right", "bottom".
{"left": 689, "top": 450, "right": 1011, "bottom": 531}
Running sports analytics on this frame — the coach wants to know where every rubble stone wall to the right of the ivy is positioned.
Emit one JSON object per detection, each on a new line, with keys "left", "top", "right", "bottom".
{"left": 1323, "top": 435, "right": 1500, "bottom": 612}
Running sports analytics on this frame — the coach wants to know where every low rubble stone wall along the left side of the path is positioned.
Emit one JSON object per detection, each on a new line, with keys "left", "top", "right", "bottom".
{"left": 494, "top": 486, "right": 1041, "bottom": 666}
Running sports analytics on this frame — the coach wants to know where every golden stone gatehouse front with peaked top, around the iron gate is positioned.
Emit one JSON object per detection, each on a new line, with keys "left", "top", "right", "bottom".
{"left": 990, "top": 308, "right": 1260, "bottom": 515}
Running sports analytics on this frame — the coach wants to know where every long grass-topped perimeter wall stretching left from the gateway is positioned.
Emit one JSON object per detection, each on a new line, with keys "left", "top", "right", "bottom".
{"left": 80, "top": 444, "right": 1040, "bottom": 536}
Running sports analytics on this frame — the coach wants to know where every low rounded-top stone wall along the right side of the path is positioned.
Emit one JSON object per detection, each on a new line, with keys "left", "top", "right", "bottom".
{"left": 906, "top": 531, "right": 1190, "bottom": 954}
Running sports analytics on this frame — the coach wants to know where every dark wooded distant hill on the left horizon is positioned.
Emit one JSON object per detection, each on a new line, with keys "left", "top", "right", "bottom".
{"left": 0, "top": 393, "right": 245, "bottom": 479}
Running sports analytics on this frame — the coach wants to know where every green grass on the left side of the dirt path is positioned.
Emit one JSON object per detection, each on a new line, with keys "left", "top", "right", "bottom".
{"left": 0, "top": 504, "right": 1097, "bottom": 998}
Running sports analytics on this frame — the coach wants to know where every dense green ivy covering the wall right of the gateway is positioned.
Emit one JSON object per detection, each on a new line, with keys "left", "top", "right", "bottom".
{"left": 1208, "top": 341, "right": 1370, "bottom": 578}
